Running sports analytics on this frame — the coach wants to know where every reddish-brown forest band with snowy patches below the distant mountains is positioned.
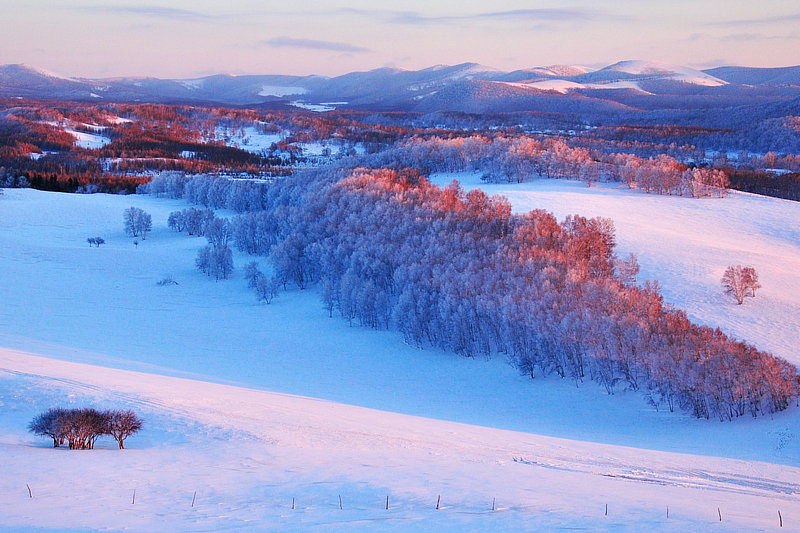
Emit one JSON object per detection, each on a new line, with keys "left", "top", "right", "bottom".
{"left": 0, "top": 99, "right": 800, "bottom": 200}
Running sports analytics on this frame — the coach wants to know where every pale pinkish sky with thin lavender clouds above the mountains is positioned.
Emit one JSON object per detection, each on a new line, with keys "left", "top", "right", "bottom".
{"left": 0, "top": 0, "right": 800, "bottom": 78}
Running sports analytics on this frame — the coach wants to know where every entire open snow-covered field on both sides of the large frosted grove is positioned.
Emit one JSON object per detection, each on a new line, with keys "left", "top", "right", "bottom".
{"left": 0, "top": 182, "right": 800, "bottom": 531}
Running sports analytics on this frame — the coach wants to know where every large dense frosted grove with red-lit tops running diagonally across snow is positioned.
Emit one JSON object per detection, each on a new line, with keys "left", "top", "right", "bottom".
{"left": 145, "top": 168, "right": 799, "bottom": 420}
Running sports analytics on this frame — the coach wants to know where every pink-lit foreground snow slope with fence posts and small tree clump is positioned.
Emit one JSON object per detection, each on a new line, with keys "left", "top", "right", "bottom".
{"left": 0, "top": 349, "right": 800, "bottom": 531}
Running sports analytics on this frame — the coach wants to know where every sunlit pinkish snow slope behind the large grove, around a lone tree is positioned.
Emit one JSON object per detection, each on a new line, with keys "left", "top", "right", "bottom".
{"left": 433, "top": 173, "right": 800, "bottom": 365}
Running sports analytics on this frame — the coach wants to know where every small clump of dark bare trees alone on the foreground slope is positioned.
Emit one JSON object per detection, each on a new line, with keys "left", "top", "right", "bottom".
{"left": 28, "top": 407, "right": 142, "bottom": 450}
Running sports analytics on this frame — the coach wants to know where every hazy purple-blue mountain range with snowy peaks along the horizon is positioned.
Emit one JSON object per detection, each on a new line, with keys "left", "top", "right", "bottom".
{"left": 0, "top": 61, "right": 800, "bottom": 112}
